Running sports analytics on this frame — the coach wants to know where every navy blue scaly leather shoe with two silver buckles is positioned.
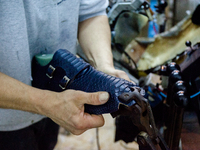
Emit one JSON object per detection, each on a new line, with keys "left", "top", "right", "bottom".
{"left": 32, "top": 49, "right": 136, "bottom": 114}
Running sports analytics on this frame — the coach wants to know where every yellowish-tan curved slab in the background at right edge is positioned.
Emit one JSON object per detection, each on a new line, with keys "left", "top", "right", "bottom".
{"left": 137, "top": 15, "right": 200, "bottom": 70}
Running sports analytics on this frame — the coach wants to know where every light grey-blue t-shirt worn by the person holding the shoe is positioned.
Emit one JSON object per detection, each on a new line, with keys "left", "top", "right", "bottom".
{"left": 0, "top": 0, "right": 108, "bottom": 131}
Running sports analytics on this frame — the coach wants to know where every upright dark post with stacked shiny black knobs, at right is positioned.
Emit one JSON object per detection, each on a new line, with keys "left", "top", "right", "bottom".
{"left": 164, "top": 64, "right": 188, "bottom": 150}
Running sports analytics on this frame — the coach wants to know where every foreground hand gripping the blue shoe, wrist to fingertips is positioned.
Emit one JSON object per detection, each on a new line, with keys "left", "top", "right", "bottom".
{"left": 43, "top": 90, "right": 109, "bottom": 135}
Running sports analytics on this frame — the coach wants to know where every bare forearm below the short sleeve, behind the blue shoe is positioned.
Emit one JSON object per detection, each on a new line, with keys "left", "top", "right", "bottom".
{"left": 78, "top": 16, "right": 113, "bottom": 69}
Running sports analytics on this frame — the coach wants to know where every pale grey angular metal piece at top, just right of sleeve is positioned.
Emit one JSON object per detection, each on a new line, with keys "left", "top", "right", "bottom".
{"left": 108, "top": 0, "right": 149, "bottom": 25}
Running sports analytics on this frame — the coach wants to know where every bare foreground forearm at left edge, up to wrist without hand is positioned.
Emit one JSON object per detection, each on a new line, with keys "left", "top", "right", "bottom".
{"left": 0, "top": 72, "right": 49, "bottom": 115}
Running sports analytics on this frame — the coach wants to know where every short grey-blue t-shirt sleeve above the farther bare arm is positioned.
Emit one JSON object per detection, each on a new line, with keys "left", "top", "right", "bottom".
{"left": 79, "top": 0, "right": 108, "bottom": 22}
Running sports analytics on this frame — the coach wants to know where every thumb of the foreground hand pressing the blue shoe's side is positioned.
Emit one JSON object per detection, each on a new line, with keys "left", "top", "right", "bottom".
{"left": 86, "top": 92, "right": 109, "bottom": 105}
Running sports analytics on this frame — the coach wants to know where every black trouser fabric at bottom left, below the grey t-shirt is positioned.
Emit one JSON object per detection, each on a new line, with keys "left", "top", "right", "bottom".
{"left": 0, "top": 118, "right": 59, "bottom": 150}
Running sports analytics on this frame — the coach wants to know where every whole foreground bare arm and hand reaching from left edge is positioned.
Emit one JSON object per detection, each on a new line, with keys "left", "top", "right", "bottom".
{"left": 0, "top": 72, "right": 108, "bottom": 135}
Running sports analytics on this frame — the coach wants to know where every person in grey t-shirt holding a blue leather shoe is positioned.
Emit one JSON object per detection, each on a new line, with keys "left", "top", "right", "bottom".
{"left": 0, "top": 0, "right": 129, "bottom": 150}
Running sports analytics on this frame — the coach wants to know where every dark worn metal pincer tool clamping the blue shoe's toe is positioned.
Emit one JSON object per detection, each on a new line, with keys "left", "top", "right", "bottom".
{"left": 111, "top": 87, "right": 169, "bottom": 150}
